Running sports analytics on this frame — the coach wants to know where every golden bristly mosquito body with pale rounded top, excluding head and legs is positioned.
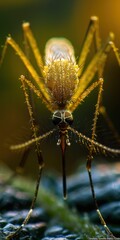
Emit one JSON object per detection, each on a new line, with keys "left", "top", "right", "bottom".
{"left": 44, "top": 38, "right": 78, "bottom": 107}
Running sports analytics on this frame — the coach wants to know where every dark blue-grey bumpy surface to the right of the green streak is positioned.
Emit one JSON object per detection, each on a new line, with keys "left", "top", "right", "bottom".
{"left": 68, "top": 164, "right": 120, "bottom": 236}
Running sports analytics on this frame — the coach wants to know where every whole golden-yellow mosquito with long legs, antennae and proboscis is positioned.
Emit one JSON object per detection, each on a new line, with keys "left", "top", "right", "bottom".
{"left": 1, "top": 16, "right": 120, "bottom": 239}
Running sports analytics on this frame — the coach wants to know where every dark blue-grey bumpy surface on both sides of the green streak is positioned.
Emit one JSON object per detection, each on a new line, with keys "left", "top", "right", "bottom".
{"left": 0, "top": 163, "right": 120, "bottom": 240}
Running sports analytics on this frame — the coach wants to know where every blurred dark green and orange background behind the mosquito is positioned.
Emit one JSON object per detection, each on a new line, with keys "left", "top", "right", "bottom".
{"left": 0, "top": 0, "right": 120, "bottom": 176}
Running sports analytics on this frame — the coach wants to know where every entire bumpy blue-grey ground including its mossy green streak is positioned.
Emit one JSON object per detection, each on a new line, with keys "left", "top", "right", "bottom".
{"left": 0, "top": 165, "right": 120, "bottom": 240}
